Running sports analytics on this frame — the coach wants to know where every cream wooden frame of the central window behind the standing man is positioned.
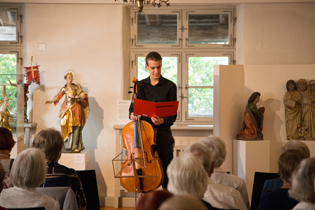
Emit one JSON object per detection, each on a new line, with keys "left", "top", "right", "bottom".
{"left": 128, "top": 6, "right": 236, "bottom": 125}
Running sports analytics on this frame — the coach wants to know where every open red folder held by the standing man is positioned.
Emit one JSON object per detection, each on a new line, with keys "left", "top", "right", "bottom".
{"left": 133, "top": 98, "right": 178, "bottom": 118}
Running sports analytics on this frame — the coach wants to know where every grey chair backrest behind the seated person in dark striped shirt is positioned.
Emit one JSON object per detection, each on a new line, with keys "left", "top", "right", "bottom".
{"left": 36, "top": 187, "right": 79, "bottom": 210}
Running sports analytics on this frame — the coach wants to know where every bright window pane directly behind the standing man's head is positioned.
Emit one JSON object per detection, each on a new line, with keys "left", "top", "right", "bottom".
{"left": 137, "top": 57, "right": 177, "bottom": 85}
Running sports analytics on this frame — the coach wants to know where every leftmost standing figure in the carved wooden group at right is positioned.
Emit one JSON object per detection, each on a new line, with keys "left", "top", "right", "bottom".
{"left": 283, "top": 80, "right": 302, "bottom": 140}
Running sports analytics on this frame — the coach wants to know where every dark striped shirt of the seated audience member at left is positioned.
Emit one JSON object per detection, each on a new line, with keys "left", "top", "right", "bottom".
{"left": 41, "top": 162, "right": 86, "bottom": 209}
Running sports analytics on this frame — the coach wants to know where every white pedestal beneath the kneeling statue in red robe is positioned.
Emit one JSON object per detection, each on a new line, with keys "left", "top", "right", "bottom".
{"left": 233, "top": 139, "right": 270, "bottom": 198}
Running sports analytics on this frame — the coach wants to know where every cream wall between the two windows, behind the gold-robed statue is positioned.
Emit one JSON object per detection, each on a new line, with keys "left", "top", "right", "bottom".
{"left": 24, "top": 4, "right": 126, "bottom": 201}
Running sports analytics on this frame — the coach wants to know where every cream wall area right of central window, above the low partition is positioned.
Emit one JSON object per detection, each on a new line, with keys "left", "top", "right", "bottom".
{"left": 236, "top": 3, "right": 315, "bottom": 65}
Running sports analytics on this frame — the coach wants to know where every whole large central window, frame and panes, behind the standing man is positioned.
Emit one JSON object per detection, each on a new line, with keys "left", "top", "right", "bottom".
{"left": 130, "top": 8, "right": 236, "bottom": 124}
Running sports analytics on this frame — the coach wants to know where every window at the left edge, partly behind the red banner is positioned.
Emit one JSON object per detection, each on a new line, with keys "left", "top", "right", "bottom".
{"left": 0, "top": 4, "right": 24, "bottom": 119}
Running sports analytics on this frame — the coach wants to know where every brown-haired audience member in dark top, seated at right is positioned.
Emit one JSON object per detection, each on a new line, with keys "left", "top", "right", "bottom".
{"left": 258, "top": 149, "right": 307, "bottom": 210}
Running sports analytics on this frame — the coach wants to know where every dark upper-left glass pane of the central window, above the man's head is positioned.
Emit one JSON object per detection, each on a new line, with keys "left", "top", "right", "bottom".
{"left": 137, "top": 14, "right": 177, "bottom": 44}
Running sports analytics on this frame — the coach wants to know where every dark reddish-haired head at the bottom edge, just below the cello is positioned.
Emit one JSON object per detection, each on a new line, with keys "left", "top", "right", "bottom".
{"left": 136, "top": 190, "right": 174, "bottom": 210}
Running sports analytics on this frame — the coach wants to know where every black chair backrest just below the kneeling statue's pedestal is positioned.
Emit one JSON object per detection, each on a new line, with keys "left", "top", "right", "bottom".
{"left": 250, "top": 172, "right": 279, "bottom": 210}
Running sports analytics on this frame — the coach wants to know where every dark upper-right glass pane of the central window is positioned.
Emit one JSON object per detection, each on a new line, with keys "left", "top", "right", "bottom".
{"left": 188, "top": 14, "right": 229, "bottom": 44}
